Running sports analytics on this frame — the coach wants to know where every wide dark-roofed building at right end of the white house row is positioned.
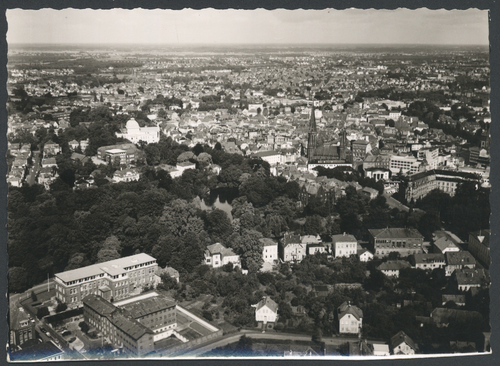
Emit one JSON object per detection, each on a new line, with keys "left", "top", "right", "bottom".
{"left": 368, "top": 228, "right": 424, "bottom": 257}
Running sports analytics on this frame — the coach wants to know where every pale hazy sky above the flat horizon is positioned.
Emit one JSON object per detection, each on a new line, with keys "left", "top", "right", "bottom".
{"left": 7, "top": 9, "right": 489, "bottom": 45}
